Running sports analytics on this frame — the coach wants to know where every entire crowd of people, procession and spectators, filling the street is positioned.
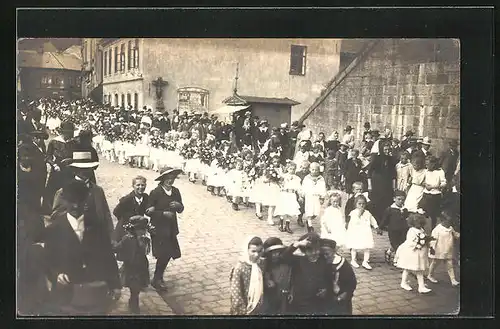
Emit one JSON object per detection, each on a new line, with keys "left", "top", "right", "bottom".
{"left": 18, "top": 99, "right": 460, "bottom": 314}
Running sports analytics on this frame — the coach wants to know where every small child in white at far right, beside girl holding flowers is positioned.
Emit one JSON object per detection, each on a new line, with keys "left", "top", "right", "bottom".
{"left": 427, "top": 211, "right": 460, "bottom": 287}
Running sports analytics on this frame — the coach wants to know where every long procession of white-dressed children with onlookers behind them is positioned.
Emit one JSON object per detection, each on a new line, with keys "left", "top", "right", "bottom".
{"left": 39, "top": 97, "right": 460, "bottom": 312}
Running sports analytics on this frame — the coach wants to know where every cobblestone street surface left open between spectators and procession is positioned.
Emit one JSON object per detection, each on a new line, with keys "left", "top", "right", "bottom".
{"left": 96, "top": 159, "right": 460, "bottom": 315}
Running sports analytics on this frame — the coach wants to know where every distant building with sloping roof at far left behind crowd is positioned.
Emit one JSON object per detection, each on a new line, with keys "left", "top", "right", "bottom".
{"left": 17, "top": 44, "right": 82, "bottom": 100}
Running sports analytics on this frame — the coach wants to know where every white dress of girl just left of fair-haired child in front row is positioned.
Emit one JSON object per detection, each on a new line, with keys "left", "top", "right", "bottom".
{"left": 274, "top": 174, "right": 301, "bottom": 216}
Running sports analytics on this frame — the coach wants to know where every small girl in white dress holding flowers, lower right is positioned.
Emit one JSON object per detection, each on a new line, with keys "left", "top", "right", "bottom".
{"left": 394, "top": 214, "right": 431, "bottom": 294}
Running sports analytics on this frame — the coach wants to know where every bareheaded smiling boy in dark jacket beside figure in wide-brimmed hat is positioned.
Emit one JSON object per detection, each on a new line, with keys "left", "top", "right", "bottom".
{"left": 113, "top": 176, "right": 148, "bottom": 242}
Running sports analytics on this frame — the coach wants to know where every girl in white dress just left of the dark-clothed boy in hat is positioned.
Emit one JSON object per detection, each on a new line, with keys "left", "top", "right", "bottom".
{"left": 346, "top": 195, "right": 382, "bottom": 270}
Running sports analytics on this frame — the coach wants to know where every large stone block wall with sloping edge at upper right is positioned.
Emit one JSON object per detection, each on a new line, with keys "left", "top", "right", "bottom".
{"left": 304, "top": 39, "right": 460, "bottom": 152}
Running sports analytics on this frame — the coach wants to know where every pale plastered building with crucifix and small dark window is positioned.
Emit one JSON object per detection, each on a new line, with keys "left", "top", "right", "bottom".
{"left": 96, "top": 38, "right": 340, "bottom": 119}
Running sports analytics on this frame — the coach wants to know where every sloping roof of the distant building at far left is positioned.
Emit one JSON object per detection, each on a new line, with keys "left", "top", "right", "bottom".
{"left": 17, "top": 50, "right": 82, "bottom": 71}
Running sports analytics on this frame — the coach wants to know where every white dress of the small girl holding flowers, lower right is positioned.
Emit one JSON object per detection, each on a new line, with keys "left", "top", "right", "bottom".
{"left": 394, "top": 227, "right": 429, "bottom": 271}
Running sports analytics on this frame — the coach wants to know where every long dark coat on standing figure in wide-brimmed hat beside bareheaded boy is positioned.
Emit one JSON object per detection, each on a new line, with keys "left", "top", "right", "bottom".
{"left": 147, "top": 185, "right": 184, "bottom": 259}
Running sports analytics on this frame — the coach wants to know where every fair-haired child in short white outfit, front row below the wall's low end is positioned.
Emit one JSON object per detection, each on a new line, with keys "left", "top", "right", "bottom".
{"left": 301, "top": 162, "right": 326, "bottom": 232}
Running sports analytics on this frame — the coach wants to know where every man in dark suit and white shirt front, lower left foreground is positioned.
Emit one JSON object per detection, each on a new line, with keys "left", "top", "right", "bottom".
{"left": 45, "top": 180, "right": 121, "bottom": 314}
